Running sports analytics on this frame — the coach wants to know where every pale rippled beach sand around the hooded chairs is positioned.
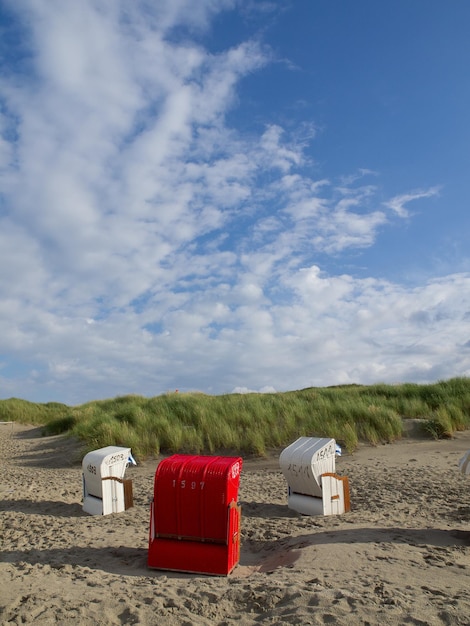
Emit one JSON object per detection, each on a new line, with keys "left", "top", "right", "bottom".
{"left": 0, "top": 424, "right": 470, "bottom": 626}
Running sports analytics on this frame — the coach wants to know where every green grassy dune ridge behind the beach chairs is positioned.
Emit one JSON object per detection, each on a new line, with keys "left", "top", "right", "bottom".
{"left": 0, "top": 378, "right": 470, "bottom": 457}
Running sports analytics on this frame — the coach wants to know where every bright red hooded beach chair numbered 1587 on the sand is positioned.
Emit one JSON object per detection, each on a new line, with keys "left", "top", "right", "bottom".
{"left": 148, "top": 454, "right": 242, "bottom": 575}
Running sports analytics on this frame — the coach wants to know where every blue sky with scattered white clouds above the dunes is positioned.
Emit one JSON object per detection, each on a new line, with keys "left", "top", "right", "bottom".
{"left": 0, "top": 0, "right": 470, "bottom": 405}
